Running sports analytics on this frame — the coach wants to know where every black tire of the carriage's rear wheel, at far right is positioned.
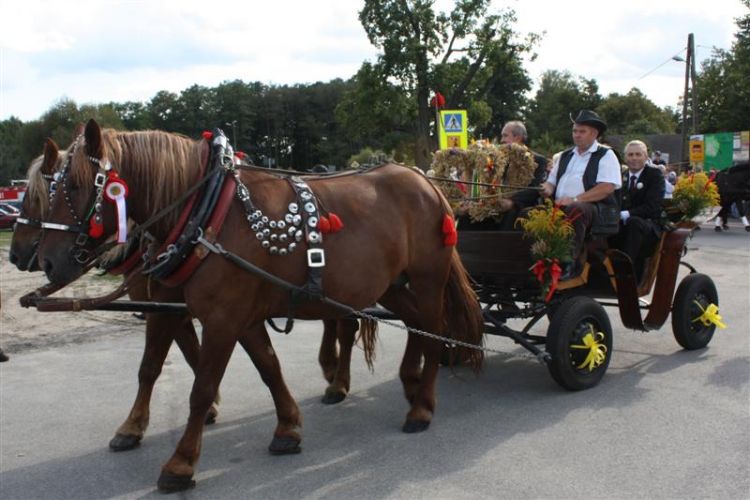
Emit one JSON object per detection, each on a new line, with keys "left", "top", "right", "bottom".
{"left": 672, "top": 273, "right": 719, "bottom": 351}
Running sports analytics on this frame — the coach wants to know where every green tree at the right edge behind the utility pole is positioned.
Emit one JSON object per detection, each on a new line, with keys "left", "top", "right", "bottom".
{"left": 696, "top": 0, "right": 750, "bottom": 133}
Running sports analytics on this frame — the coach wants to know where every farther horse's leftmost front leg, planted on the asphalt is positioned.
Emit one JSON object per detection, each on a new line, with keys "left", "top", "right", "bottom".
{"left": 109, "top": 314, "right": 187, "bottom": 451}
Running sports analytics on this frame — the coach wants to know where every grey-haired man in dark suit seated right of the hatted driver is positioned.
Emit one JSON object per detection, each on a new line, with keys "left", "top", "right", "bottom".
{"left": 613, "top": 141, "right": 664, "bottom": 277}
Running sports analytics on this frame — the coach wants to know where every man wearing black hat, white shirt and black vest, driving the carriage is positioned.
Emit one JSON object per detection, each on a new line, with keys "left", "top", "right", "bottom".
{"left": 542, "top": 109, "right": 622, "bottom": 280}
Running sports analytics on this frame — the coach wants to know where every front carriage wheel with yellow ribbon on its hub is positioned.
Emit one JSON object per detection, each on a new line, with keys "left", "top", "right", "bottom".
{"left": 547, "top": 297, "right": 612, "bottom": 391}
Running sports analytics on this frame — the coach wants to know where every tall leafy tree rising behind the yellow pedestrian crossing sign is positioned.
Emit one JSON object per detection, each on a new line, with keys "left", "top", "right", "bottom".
{"left": 359, "top": 0, "right": 533, "bottom": 168}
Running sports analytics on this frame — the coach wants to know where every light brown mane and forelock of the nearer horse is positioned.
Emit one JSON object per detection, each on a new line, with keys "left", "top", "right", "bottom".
{"left": 70, "top": 129, "right": 202, "bottom": 228}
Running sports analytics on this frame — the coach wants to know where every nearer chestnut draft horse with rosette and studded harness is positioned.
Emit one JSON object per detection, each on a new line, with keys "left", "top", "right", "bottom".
{"left": 39, "top": 120, "right": 483, "bottom": 491}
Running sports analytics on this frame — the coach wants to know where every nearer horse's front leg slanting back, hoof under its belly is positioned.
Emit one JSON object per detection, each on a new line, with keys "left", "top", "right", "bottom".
{"left": 239, "top": 323, "right": 302, "bottom": 455}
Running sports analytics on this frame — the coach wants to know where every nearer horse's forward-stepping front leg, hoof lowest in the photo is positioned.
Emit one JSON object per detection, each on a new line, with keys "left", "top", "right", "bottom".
{"left": 157, "top": 325, "right": 237, "bottom": 493}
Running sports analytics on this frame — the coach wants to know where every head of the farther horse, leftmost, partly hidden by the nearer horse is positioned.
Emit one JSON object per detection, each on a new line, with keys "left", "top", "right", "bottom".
{"left": 9, "top": 139, "right": 67, "bottom": 271}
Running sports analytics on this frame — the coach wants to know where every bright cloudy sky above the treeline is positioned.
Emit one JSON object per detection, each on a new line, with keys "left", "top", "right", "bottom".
{"left": 0, "top": 0, "right": 747, "bottom": 121}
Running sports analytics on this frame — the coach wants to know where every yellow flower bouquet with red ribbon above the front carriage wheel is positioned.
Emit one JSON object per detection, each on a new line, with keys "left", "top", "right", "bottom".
{"left": 518, "top": 200, "right": 576, "bottom": 302}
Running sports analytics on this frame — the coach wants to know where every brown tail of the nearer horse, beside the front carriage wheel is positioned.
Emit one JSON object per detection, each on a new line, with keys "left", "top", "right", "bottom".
{"left": 443, "top": 249, "right": 484, "bottom": 371}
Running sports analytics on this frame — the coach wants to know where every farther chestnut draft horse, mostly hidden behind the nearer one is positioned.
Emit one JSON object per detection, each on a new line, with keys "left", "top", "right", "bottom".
{"left": 10, "top": 137, "right": 375, "bottom": 451}
